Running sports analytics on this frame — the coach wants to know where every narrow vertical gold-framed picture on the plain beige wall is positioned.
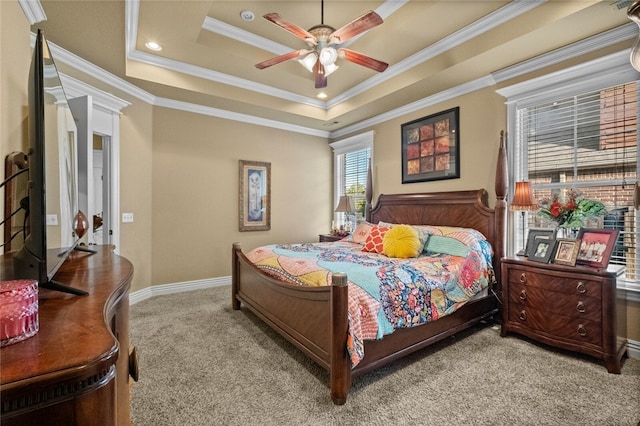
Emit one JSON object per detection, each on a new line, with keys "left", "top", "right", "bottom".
{"left": 238, "top": 160, "right": 271, "bottom": 231}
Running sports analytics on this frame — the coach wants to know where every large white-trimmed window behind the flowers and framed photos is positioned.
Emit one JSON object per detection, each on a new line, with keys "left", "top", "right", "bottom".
{"left": 499, "top": 51, "right": 640, "bottom": 286}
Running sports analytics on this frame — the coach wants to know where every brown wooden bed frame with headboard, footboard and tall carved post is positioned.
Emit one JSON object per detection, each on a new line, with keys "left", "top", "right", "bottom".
{"left": 232, "top": 135, "right": 507, "bottom": 404}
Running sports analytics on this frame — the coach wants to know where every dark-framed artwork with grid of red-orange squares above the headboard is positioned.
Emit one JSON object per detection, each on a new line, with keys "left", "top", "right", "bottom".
{"left": 401, "top": 107, "right": 460, "bottom": 183}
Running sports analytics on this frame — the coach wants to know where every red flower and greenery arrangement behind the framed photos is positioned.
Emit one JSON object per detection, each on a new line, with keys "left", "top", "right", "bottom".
{"left": 538, "top": 189, "right": 607, "bottom": 228}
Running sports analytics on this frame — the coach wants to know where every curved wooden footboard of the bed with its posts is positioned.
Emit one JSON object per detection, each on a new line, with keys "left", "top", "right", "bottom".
{"left": 231, "top": 243, "right": 351, "bottom": 404}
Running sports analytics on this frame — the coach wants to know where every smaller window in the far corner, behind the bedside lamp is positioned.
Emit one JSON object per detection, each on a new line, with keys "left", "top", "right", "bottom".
{"left": 331, "top": 132, "right": 373, "bottom": 229}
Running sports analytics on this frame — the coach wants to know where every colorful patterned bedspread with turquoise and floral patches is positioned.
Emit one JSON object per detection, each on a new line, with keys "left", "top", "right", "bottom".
{"left": 247, "top": 228, "right": 495, "bottom": 366}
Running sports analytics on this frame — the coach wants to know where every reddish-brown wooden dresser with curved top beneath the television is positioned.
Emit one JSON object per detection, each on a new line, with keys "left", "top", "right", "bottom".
{"left": 0, "top": 246, "right": 137, "bottom": 426}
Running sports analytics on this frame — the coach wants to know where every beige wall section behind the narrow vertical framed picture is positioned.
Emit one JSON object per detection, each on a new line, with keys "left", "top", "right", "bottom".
{"left": 152, "top": 108, "right": 333, "bottom": 284}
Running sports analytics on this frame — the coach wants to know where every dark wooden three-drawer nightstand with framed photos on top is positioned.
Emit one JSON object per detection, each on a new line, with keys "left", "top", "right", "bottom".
{"left": 500, "top": 257, "right": 627, "bottom": 374}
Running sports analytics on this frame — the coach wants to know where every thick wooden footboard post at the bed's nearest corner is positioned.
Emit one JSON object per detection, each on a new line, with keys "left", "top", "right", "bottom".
{"left": 329, "top": 272, "right": 351, "bottom": 405}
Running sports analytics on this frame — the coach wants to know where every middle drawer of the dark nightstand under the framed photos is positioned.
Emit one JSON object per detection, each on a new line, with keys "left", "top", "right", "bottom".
{"left": 508, "top": 282, "right": 602, "bottom": 321}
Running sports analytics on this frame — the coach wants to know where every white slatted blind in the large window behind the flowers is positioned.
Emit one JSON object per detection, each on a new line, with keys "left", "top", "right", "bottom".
{"left": 514, "top": 81, "right": 640, "bottom": 280}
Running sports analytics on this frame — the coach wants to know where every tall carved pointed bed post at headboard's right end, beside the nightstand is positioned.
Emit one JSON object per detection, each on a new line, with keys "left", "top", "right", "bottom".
{"left": 494, "top": 130, "right": 509, "bottom": 290}
